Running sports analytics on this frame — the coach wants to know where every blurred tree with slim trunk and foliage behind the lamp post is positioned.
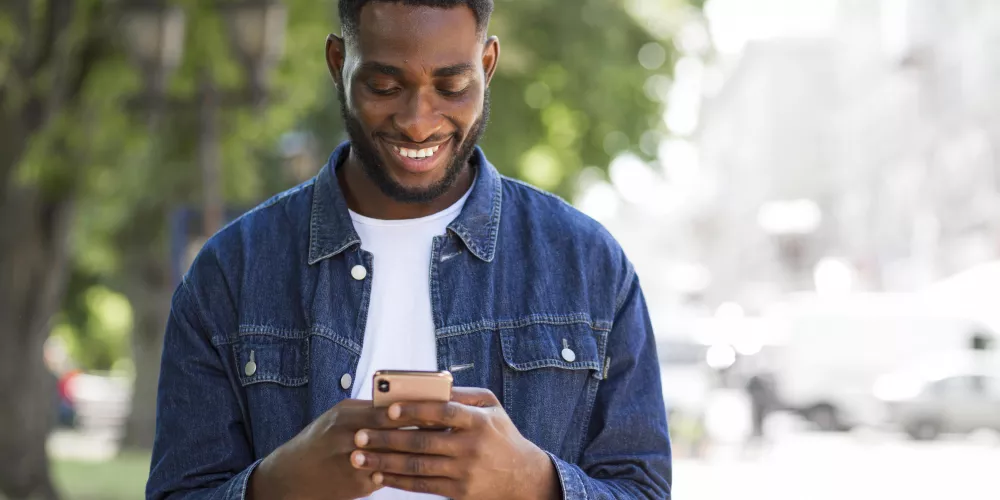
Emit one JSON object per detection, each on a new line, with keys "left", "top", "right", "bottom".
{"left": 86, "top": 0, "right": 335, "bottom": 448}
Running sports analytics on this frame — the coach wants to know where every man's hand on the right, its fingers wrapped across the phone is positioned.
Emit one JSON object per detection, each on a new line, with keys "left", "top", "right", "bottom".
{"left": 351, "top": 388, "right": 560, "bottom": 500}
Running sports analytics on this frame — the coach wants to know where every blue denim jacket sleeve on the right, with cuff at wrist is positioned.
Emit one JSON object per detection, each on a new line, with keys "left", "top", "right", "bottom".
{"left": 550, "top": 267, "right": 672, "bottom": 500}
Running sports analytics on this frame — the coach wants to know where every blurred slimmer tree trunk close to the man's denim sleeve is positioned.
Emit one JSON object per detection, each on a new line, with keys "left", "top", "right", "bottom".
{"left": 120, "top": 207, "right": 173, "bottom": 450}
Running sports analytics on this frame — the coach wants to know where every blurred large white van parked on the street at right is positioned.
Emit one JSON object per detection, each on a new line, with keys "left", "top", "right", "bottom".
{"left": 767, "top": 293, "right": 996, "bottom": 430}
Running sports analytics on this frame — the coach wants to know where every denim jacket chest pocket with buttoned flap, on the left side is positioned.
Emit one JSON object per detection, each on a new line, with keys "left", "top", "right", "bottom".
{"left": 233, "top": 333, "right": 309, "bottom": 457}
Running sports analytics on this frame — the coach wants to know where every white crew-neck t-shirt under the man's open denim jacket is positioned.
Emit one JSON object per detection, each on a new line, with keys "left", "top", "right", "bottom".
{"left": 351, "top": 185, "right": 472, "bottom": 500}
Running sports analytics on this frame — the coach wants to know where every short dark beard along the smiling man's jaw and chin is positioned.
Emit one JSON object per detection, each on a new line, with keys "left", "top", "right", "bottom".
{"left": 337, "top": 88, "right": 490, "bottom": 203}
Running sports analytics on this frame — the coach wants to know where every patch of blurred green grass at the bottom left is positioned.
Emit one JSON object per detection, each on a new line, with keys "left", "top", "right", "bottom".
{"left": 52, "top": 452, "right": 149, "bottom": 500}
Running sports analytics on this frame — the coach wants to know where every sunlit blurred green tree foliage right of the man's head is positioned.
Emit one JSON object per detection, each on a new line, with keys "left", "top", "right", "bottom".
{"left": 483, "top": 0, "right": 688, "bottom": 198}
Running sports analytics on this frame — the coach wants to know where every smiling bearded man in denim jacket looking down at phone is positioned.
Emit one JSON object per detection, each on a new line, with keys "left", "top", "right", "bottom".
{"left": 147, "top": 0, "right": 671, "bottom": 500}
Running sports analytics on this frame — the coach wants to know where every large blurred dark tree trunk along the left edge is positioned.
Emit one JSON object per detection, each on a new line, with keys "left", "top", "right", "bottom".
{"left": 0, "top": 0, "right": 119, "bottom": 498}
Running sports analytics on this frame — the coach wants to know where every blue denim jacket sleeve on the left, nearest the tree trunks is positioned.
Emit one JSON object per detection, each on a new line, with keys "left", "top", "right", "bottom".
{"left": 146, "top": 280, "right": 259, "bottom": 500}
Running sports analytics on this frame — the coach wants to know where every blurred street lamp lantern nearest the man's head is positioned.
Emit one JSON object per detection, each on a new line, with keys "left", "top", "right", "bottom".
{"left": 223, "top": 0, "right": 287, "bottom": 106}
